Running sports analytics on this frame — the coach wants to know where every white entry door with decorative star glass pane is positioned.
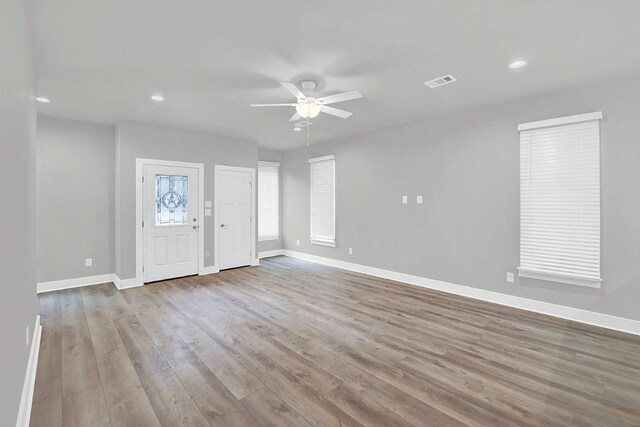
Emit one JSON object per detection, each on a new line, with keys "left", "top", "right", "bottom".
{"left": 142, "top": 165, "right": 200, "bottom": 282}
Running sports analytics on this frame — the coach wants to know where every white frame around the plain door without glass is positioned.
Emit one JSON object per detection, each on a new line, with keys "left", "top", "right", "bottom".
{"left": 213, "top": 165, "right": 260, "bottom": 270}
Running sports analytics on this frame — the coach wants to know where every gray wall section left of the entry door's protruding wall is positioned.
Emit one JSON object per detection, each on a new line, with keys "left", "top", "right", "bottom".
{"left": 36, "top": 116, "right": 115, "bottom": 282}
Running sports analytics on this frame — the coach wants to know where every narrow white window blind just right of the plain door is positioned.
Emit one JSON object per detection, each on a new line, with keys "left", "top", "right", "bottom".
{"left": 258, "top": 162, "right": 280, "bottom": 242}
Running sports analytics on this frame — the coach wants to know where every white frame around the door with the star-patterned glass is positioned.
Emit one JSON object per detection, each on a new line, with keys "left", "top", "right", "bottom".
{"left": 136, "top": 158, "right": 205, "bottom": 285}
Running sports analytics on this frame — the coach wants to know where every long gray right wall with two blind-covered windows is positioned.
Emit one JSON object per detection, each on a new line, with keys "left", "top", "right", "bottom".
{"left": 283, "top": 75, "right": 640, "bottom": 320}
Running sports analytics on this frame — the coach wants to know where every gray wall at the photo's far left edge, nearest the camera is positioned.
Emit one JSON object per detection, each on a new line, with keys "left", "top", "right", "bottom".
{"left": 0, "top": 0, "right": 36, "bottom": 426}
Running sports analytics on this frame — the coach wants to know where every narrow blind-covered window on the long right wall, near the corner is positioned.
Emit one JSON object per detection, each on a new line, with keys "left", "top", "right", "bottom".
{"left": 309, "top": 156, "right": 336, "bottom": 247}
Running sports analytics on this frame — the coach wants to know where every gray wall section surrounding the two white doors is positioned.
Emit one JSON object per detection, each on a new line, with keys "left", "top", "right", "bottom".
{"left": 115, "top": 122, "right": 258, "bottom": 279}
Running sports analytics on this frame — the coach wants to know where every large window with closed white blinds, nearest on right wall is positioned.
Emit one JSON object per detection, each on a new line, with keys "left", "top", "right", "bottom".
{"left": 518, "top": 112, "right": 602, "bottom": 288}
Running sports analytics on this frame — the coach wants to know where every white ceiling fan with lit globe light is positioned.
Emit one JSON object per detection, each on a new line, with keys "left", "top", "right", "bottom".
{"left": 251, "top": 80, "right": 362, "bottom": 126}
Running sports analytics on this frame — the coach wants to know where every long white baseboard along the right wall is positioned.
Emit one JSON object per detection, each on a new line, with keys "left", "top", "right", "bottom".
{"left": 284, "top": 250, "right": 640, "bottom": 335}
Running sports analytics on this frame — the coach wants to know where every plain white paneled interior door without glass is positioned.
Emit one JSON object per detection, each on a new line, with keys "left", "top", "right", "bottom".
{"left": 217, "top": 169, "right": 253, "bottom": 270}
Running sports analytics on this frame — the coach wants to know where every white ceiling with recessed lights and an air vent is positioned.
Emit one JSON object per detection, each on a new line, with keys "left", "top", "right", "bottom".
{"left": 28, "top": 0, "right": 640, "bottom": 149}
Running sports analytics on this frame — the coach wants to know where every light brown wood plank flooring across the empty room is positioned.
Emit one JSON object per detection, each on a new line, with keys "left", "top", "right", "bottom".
{"left": 32, "top": 257, "right": 640, "bottom": 427}
